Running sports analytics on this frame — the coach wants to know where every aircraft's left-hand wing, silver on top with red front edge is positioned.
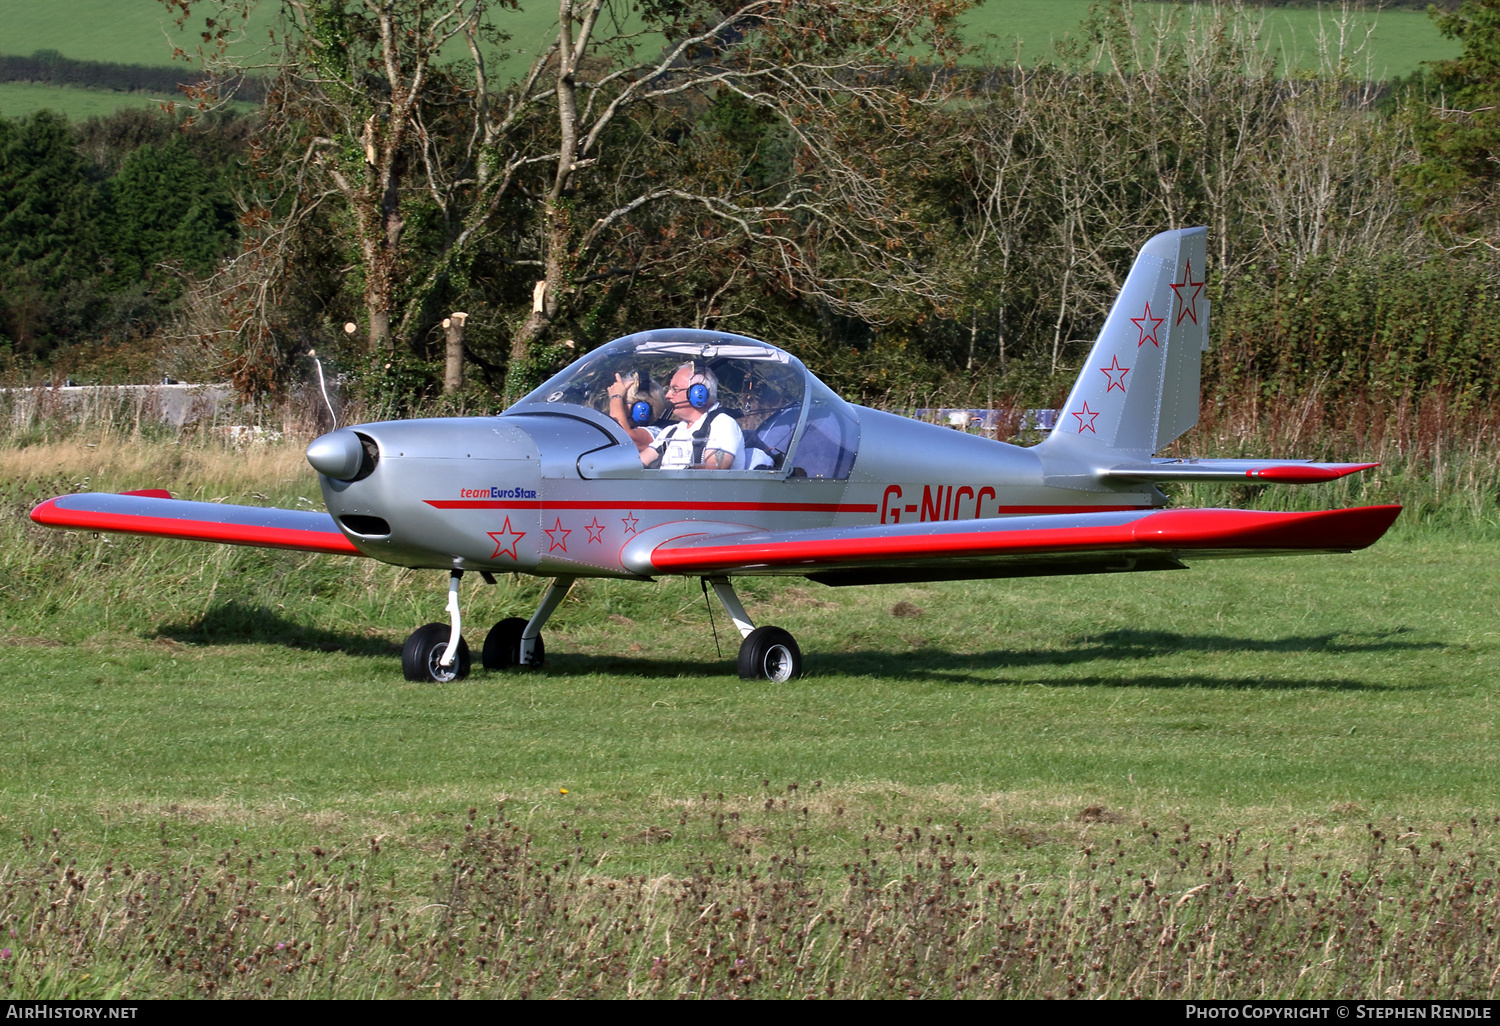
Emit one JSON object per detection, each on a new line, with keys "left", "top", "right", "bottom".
{"left": 32, "top": 495, "right": 363, "bottom": 555}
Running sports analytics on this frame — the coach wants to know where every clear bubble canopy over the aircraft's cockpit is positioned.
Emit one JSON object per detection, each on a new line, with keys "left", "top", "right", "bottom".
{"left": 507, "top": 329, "right": 860, "bottom": 480}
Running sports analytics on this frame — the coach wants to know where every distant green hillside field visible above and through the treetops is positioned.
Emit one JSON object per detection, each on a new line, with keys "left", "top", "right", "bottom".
{"left": 0, "top": 0, "right": 1458, "bottom": 117}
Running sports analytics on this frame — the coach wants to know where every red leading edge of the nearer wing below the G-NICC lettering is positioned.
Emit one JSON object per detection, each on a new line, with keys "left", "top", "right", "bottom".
{"left": 651, "top": 506, "right": 1401, "bottom": 573}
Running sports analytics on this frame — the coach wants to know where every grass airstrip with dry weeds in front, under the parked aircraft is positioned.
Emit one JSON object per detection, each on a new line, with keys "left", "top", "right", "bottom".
{"left": 0, "top": 414, "right": 1500, "bottom": 996}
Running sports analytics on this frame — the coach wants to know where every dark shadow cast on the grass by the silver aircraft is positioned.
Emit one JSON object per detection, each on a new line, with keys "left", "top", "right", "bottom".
{"left": 153, "top": 602, "right": 1448, "bottom": 692}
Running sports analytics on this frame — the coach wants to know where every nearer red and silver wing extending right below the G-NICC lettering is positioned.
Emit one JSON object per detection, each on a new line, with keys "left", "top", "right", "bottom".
{"left": 639, "top": 506, "right": 1401, "bottom": 585}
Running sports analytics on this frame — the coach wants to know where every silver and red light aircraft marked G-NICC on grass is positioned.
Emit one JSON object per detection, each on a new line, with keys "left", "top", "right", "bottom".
{"left": 32, "top": 228, "right": 1401, "bottom": 681}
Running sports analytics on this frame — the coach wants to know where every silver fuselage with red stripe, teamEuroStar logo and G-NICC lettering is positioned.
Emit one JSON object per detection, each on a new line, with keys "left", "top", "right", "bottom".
{"left": 320, "top": 407, "right": 1166, "bottom": 579}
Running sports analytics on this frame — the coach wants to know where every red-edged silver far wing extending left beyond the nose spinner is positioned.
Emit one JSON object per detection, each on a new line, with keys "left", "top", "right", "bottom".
{"left": 32, "top": 489, "right": 363, "bottom": 555}
